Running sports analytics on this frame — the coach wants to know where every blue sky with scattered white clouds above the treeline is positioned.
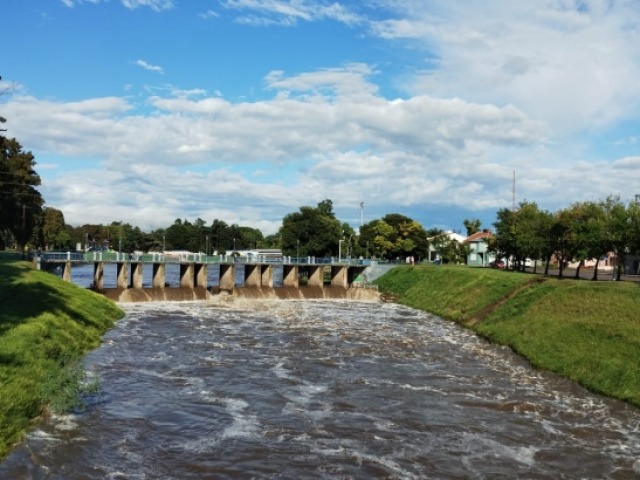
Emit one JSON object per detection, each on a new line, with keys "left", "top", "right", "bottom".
{"left": 0, "top": 0, "right": 640, "bottom": 235}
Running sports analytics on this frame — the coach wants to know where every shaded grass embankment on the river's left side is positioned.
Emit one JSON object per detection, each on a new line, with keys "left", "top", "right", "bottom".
{"left": 0, "top": 259, "right": 123, "bottom": 458}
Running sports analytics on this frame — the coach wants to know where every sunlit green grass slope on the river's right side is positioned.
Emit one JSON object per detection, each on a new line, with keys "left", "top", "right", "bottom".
{"left": 376, "top": 266, "right": 640, "bottom": 406}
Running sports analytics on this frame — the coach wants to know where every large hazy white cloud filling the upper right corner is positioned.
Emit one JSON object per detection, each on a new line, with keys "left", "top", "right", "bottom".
{"left": 371, "top": 0, "right": 640, "bottom": 132}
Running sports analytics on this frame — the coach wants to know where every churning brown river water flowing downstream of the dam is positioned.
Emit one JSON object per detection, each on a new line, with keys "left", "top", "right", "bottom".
{"left": 0, "top": 299, "right": 640, "bottom": 480}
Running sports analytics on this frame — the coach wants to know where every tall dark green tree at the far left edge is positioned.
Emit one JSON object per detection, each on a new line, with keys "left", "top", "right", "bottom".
{"left": 0, "top": 136, "right": 44, "bottom": 250}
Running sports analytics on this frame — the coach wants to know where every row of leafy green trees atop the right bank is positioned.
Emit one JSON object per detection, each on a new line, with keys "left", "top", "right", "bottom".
{"left": 490, "top": 196, "right": 640, "bottom": 280}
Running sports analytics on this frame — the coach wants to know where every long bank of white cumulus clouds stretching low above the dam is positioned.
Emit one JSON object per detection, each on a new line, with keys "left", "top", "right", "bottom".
{"left": 6, "top": 65, "right": 560, "bottom": 232}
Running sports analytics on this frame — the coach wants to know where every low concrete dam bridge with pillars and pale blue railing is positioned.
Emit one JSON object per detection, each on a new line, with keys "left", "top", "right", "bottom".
{"left": 35, "top": 252, "right": 375, "bottom": 293}
